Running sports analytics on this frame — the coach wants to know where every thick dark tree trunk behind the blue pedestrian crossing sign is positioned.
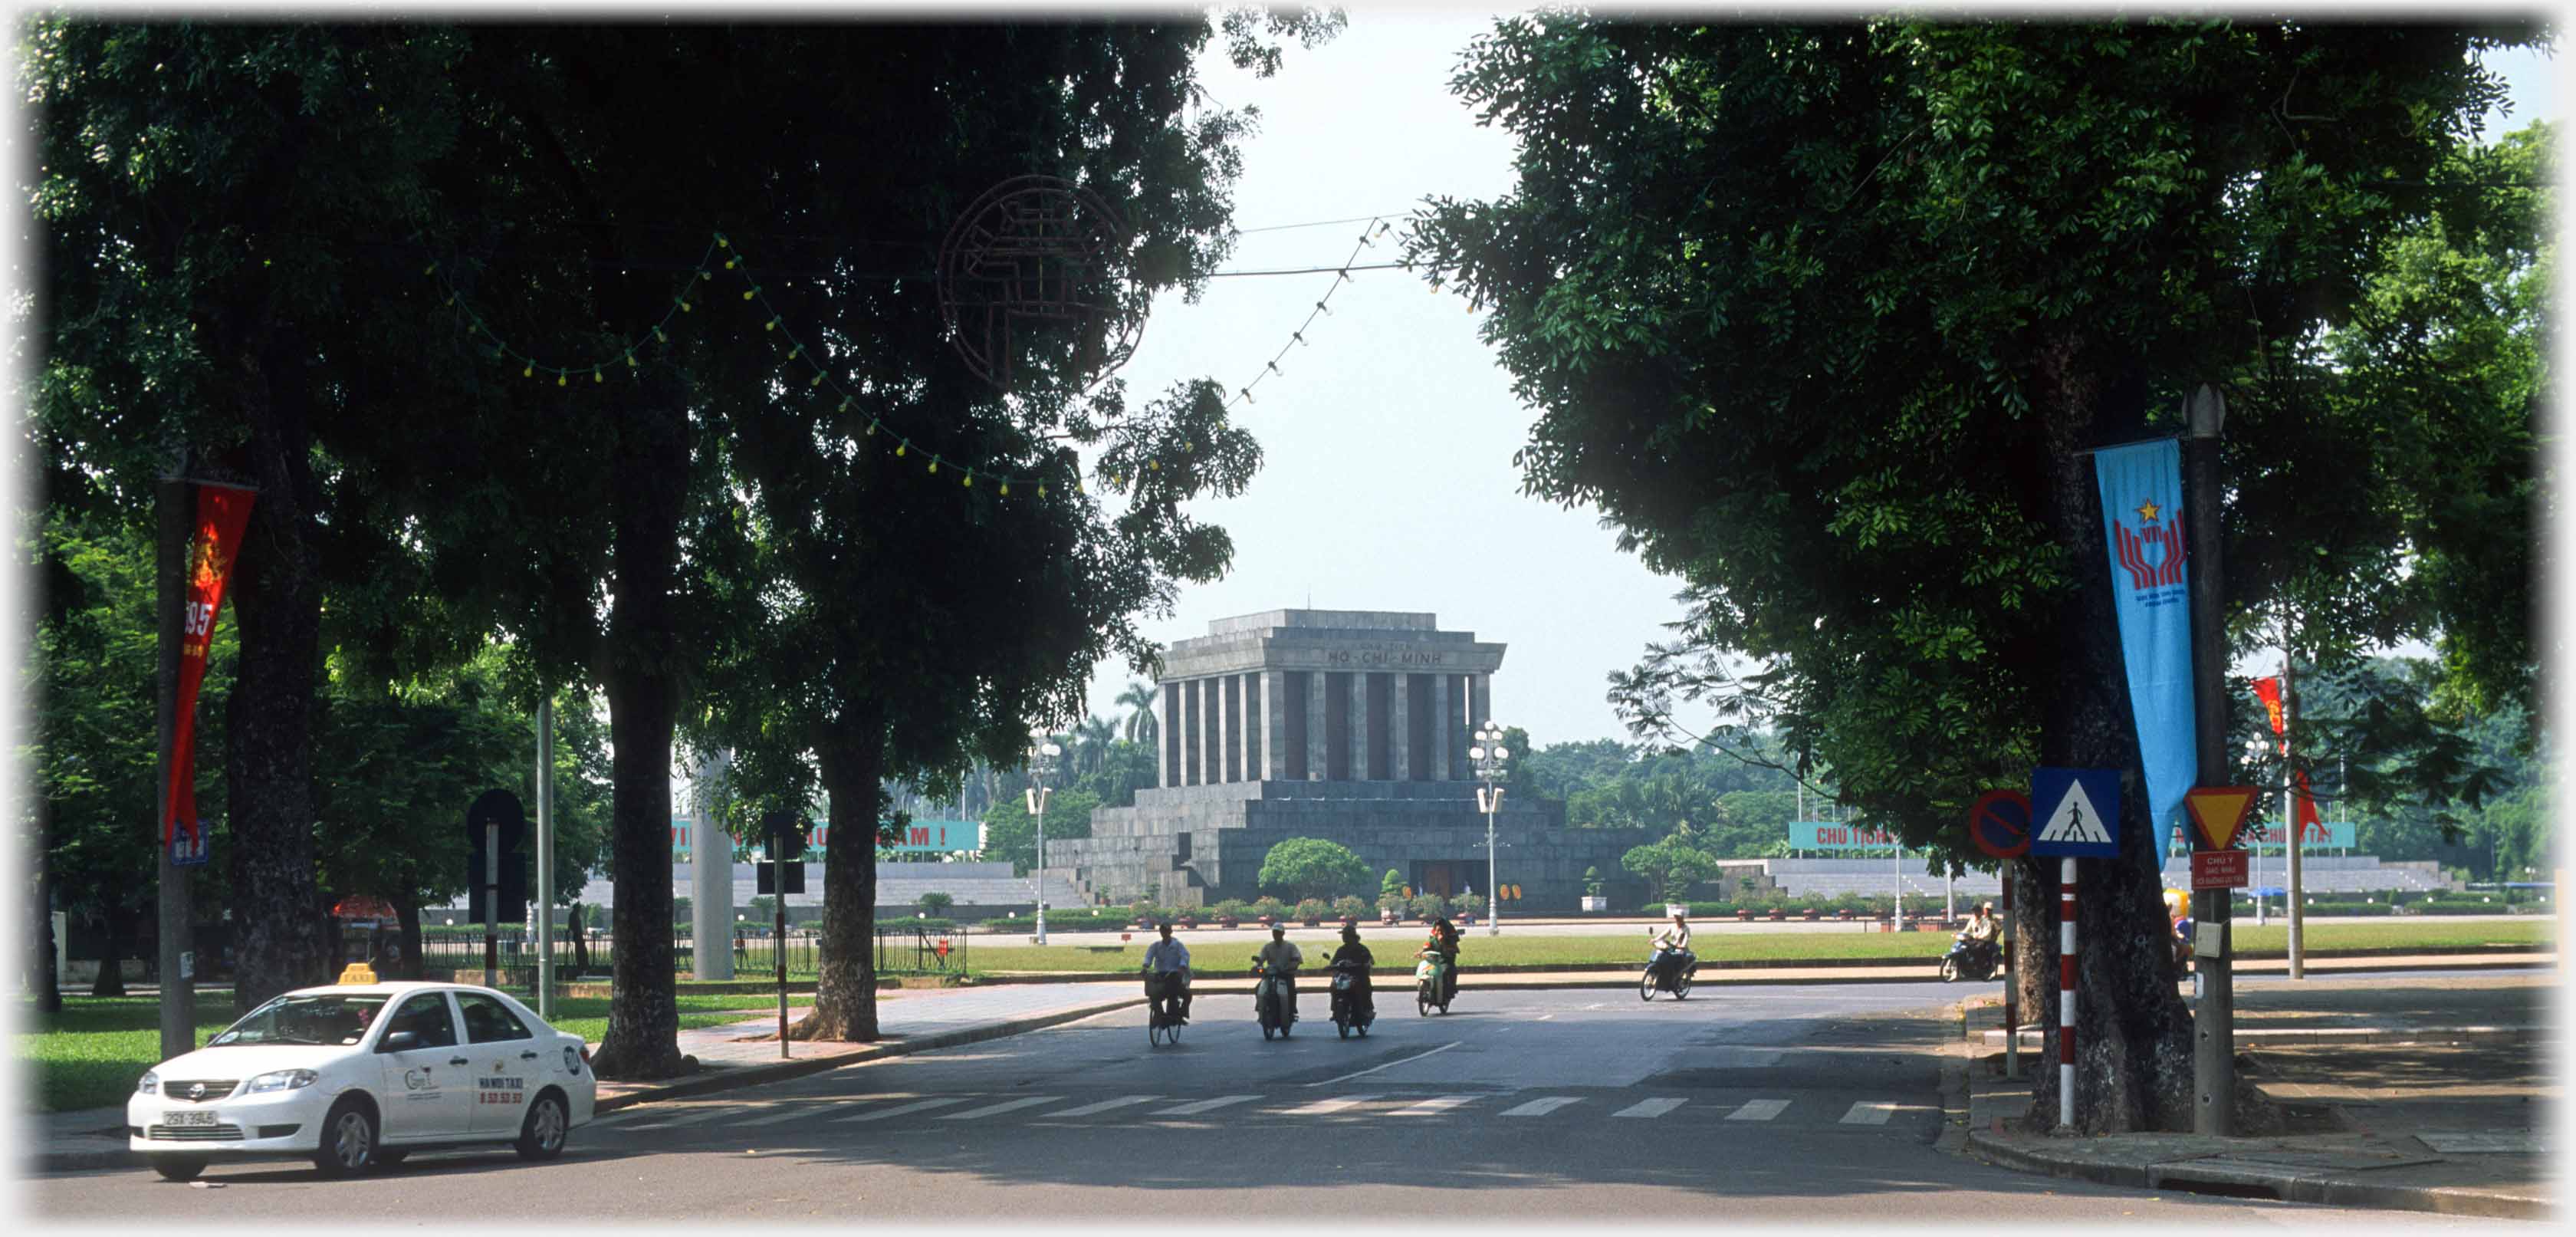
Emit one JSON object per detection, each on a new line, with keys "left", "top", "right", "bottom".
{"left": 2017, "top": 337, "right": 2192, "bottom": 1134}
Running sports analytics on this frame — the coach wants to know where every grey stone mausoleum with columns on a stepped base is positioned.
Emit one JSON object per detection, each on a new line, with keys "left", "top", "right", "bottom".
{"left": 1046, "top": 610, "right": 1651, "bottom": 915}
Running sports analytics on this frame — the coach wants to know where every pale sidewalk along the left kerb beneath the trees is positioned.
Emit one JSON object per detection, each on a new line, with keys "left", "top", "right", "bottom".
{"left": 21, "top": 982, "right": 1144, "bottom": 1173}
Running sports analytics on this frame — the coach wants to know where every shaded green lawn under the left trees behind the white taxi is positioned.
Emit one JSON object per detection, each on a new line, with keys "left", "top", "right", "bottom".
{"left": 15, "top": 995, "right": 814, "bottom": 1114}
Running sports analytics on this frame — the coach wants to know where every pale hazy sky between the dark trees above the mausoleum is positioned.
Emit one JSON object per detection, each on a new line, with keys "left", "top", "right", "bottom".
{"left": 1089, "top": 8, "right": 2563, "bottom": 745}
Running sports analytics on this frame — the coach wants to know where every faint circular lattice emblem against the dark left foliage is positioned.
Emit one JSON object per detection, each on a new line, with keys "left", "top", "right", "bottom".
{"left": 938, "top": 176, "right": 1144, "bottom": 394}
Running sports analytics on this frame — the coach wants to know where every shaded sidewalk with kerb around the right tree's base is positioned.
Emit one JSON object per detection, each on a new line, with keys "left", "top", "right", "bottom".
{"left": 1950, "top": 966, "right": 2563, "bottom": 1219}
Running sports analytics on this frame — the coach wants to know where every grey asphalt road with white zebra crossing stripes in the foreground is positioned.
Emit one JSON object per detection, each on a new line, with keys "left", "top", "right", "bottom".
{"left": 21, "top": 982, "right": 2440, "bottom": 1224}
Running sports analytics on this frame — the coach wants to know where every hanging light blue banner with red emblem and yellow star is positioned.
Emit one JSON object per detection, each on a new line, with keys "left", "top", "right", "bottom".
{"left": 2095, "top": 438, "right": 2200, "bottom": 855}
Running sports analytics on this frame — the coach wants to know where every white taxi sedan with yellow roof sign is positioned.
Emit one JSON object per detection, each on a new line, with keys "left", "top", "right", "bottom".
{"left": 127, "top": 966, "right": 598, "bottom": 1180}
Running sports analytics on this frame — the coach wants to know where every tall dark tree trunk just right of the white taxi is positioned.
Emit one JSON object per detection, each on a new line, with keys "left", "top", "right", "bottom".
{"left": 593, "top": 391, "right": 690, "bottom": 1080}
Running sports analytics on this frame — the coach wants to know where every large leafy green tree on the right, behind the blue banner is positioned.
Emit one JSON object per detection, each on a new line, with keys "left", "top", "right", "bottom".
{"left": 1409, "top": 13, "right": 2532, "bottom": 1131}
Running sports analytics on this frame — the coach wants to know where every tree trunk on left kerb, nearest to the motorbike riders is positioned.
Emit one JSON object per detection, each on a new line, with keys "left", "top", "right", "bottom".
{"left": 791, "top": 706, "right": 886, "bottom": 1041}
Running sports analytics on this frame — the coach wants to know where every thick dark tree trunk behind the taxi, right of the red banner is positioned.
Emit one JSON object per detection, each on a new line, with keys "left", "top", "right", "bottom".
{"left": 224, "top": 345, "right": 330, "bottom": 1013}
